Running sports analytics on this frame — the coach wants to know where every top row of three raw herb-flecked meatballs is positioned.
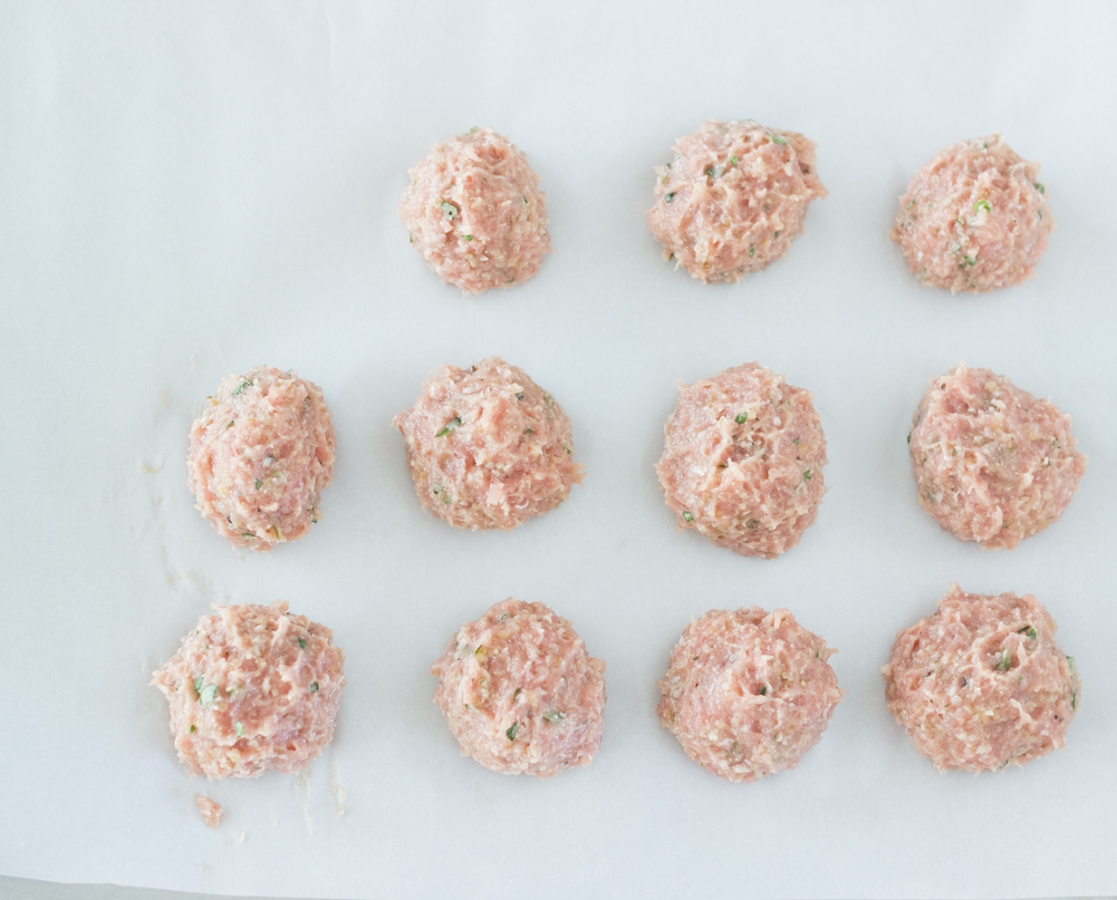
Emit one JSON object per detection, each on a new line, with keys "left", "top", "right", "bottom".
{"left": 399, "top": 121, "right": 1054, "bottom": 294}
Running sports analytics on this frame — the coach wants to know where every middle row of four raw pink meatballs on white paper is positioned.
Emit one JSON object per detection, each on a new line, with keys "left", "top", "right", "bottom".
{"left": 187, "top": 357, "right": 1086, "bottom": 558}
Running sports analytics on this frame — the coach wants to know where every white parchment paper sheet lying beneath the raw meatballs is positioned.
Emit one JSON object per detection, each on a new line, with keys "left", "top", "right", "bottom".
{"left": 0, "top": 0, "right": 1117, "bottom": 898}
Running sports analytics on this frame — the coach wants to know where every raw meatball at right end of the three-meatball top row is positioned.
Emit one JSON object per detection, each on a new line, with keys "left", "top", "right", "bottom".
{"left": 892, "top": 134, "right": 1054, "bottom": 294}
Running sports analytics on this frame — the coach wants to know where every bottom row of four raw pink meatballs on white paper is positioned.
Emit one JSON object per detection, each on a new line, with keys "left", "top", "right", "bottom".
{"left": 154, "top": 584, "right": 1080, "bottom": 790}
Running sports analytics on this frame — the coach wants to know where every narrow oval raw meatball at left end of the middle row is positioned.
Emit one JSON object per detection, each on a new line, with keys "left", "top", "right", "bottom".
{"left": 187, "top": 366, "right": 334, "bottom": 550}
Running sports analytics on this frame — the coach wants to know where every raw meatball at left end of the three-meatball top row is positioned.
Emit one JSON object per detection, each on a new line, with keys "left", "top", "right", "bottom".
{"left": 400, "top": 128, "right": 551, "bottom": 294}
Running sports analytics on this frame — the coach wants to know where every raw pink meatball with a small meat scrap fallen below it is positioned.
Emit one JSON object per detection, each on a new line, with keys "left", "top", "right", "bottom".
{"left": 152, "top": 601, "right": 345, "bottom": 778}
